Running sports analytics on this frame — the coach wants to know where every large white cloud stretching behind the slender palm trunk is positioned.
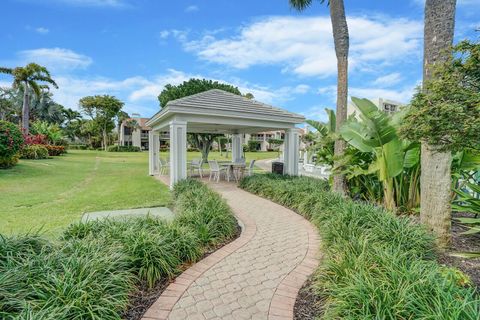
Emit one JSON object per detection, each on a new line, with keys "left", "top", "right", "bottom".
{"left": 179, "top": 16, "right": 423, "bottom": 76}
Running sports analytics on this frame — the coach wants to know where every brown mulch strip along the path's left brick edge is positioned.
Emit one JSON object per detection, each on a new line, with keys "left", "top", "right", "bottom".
{"left": 122, "top": 225, "right": 242, "bottom": 320}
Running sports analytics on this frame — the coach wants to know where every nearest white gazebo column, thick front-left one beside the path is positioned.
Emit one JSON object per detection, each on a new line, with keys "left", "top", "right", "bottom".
{"left": 170, "top": 120, "right": 187, "bottom": 189}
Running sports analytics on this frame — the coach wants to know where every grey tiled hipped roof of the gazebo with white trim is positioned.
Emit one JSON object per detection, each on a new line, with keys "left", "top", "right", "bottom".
{"left": 146, "top": 89, "right": 305, "bottom": 133}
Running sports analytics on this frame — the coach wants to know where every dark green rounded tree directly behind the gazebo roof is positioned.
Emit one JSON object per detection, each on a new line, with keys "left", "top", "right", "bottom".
{"left": 158, "top": 79, "right": 242, "bottom": 162}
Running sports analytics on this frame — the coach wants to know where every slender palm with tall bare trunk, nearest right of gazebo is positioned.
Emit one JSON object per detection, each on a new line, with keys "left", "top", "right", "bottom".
{"left": 289, "top": 0, "right": 349, "bottom": 194}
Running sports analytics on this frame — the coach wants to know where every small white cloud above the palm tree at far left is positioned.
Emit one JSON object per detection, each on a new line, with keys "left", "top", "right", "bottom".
{"left": 18, "top": 48, "right": 93, "bottom": 72}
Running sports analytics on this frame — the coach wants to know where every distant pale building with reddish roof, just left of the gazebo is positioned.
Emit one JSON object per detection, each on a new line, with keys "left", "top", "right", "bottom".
{"left": 119, "top": 113, "right": 169, "bottom": 150}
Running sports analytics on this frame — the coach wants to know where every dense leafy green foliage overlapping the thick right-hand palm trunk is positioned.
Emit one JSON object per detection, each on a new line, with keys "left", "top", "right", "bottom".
{"left": 401, "top": 41, "right": 480, "bottom": 151}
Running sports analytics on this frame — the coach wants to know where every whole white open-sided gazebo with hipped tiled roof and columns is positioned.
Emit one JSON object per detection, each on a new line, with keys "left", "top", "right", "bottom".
{"left": 146, "top": 89, "right": 305, "bottom": 187}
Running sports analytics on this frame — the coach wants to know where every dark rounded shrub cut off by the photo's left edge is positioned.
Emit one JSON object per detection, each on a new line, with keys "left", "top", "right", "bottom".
{"left": 0, "top": 121, "right": 23, "bottom": 168}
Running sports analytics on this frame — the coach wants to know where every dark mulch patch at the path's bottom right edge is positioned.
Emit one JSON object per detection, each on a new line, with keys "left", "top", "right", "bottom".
{"left": 293, "top": 277, "right": 325, "bottom": 320}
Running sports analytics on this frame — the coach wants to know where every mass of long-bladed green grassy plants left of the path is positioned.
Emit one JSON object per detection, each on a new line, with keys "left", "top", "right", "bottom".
{"left": 0, "top": 181, "right": 237, "bottom": 320}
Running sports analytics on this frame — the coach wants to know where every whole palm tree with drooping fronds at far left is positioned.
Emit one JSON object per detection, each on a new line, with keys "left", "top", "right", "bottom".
{"left": 0, "top": 63, "right": 58, "bottom": 134}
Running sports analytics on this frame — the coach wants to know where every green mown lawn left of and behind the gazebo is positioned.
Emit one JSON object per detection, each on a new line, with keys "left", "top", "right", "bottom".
{"left": 0, "top": 150, "right": 277, "bottom": 238}
